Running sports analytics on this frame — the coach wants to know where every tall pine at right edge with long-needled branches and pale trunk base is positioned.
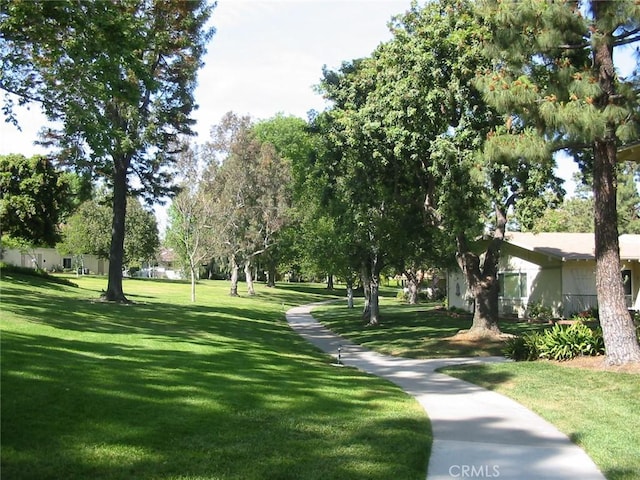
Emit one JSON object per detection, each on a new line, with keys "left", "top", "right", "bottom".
{"left": 478, "top": 0, "right": 640, "bottom": 364}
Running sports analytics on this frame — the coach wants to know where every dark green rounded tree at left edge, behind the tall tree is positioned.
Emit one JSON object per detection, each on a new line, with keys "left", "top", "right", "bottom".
{"left": 0, "top": 155, "right": 72, "bottom": 246}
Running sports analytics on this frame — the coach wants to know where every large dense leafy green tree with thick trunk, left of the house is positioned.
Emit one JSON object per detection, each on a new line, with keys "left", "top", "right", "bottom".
{"left": 318, "top": 0, "right": 562, "bottom": 336}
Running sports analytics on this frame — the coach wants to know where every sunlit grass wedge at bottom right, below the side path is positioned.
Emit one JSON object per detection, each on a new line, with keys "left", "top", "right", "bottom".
{"left": 441, "top": 361, "right": 640, "bottom": 480}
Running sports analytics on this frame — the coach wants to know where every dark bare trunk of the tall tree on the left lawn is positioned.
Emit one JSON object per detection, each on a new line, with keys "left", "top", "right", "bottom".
{"left": 104, "top": 158, "right": 129, "bottom": 303}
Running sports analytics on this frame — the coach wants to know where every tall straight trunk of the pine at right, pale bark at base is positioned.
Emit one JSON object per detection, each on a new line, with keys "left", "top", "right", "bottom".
{"left": 593, "top": 1, "right": 640, "bottom": 365}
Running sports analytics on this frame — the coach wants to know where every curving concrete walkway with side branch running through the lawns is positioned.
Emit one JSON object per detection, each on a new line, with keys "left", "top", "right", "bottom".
{"left": 286, "top": 305, "right": 605, "bottom": 480}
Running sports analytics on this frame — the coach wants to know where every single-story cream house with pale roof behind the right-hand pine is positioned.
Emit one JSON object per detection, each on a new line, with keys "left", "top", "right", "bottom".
{"left": 447, "top": 232, "right": 640, "bottom": 318}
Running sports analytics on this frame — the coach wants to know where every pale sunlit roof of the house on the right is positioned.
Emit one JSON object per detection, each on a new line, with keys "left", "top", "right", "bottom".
{"left": 505, "top": 232, "right": 640, "bottom": 261}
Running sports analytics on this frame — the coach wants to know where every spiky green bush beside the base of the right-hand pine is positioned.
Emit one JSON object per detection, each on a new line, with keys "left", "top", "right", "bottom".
{"left": 504, "top": 322, "right": 604, "bottom": 361}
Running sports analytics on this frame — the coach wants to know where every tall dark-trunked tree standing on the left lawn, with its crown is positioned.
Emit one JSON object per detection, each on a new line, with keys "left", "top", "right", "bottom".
{"left": 0, "top": 0, "right": 214, "bottom": 301}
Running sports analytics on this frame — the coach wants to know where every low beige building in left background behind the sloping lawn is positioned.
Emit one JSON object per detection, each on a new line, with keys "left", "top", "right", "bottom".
{"left": 0, "top": 248, "right": 109, "bottom": 275}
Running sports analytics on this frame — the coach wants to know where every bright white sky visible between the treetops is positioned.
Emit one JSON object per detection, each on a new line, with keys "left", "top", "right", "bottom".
{"left": 0, "top": 0, "right": 632, "bottom": 220}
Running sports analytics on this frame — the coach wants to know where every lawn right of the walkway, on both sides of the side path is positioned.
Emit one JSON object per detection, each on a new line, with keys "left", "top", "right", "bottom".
{"left": 313, "top": 298, "right": 640, "bottom": 480}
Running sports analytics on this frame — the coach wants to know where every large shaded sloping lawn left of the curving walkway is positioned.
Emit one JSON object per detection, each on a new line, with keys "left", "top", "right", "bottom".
{"left": 0, "top": 272, "right": 431, "bottom": 480}
